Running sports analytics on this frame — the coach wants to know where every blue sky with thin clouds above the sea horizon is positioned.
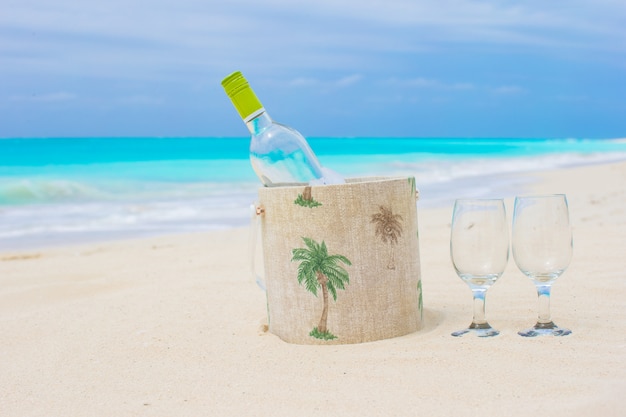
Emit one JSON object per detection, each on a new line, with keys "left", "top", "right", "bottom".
{"left": 0, "top": 0, "right": 626, "bottom": 138}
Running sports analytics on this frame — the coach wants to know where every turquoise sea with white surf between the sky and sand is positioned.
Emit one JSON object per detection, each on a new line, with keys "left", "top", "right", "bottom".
{"left": 0, "top": 138, "right": 626, "bottom": 250}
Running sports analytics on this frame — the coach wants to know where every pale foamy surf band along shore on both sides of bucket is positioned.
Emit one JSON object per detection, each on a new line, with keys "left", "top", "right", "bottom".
{"left": 0, "top": 148, "right": 626, "bottom": 250}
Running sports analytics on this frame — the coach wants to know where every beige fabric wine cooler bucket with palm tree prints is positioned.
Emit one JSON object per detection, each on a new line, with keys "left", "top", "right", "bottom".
{"left": 255, "top": 177, "right": 423, "bottom": 344}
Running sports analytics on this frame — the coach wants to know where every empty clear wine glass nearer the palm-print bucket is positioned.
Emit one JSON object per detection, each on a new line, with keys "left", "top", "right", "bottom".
{"left": 450, "top": 199, "right": 509, "bottom": 337}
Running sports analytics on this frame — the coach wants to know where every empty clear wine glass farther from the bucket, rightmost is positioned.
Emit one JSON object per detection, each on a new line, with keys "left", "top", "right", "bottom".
{"left": 512, "top": 194, "right": 572, "bottom": 337}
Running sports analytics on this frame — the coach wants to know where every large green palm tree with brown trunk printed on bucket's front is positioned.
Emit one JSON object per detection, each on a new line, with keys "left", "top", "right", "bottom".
{"left": 291, "top": 237, "right": 352, "bottom": 340}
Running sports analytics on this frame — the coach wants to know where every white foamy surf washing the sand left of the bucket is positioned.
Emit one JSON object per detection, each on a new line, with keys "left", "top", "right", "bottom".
{"left": 0, "top": 180, "right": 257, "bottom": 250}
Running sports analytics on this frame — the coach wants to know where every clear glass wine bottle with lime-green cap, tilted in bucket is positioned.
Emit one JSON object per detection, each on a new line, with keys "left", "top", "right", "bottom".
{"left": 222, "top": 71, "right": 344, "bottom": 187}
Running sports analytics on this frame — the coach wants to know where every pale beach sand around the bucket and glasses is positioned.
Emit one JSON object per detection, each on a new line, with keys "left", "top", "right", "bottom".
{"left": 0, "top": 159, "right": 626, "bottom": 417}
